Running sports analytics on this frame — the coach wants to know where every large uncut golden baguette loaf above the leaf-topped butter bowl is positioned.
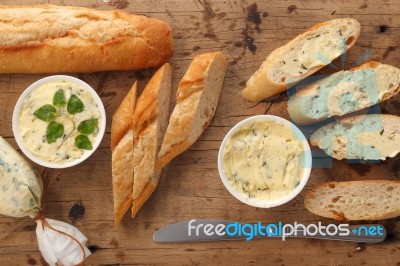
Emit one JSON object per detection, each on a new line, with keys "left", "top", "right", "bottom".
{"left": 0, "top": 5, "right": 172, "bottom": 73}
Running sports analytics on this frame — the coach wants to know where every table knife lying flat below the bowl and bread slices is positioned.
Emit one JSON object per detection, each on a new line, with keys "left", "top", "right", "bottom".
{"left": 153, "top": 219, "right": 387, "bottom": 243}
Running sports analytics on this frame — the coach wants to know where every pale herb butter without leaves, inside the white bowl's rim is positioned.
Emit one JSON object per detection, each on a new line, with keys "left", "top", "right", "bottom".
{"left": 223, "top": 120, "right": 304, "bottom": 199}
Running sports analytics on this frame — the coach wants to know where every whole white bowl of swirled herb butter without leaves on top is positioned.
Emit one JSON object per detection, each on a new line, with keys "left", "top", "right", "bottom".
{"left": 218, "top": 115, "right": 312, "bottom": 208}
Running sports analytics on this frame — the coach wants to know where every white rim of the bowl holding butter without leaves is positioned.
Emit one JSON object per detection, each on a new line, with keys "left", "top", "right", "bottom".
{"left": 218, "top": 115, "right": 312, "bottom": 208}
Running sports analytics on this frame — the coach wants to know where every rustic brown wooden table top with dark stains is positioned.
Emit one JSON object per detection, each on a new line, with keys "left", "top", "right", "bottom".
{"left": 0, "top": 0, "right": 400, "bottom": 265}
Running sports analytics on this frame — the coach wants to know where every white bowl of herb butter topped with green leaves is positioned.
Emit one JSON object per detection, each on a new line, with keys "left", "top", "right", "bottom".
{"left": 12, "top": 75, "right": 106, "bottom": 168}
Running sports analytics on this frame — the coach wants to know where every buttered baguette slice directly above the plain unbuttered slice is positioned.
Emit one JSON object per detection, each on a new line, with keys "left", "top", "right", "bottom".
{"left": 310, "top": 114, "right": 400, "bottom": 160}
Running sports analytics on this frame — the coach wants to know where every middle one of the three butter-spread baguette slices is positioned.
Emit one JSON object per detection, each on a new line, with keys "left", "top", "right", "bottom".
{"left": 288, "top": 61, "right": 400, "bottom": 125}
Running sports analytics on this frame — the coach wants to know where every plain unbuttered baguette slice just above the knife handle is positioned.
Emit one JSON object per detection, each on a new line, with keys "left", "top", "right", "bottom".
{"left": 304, "top": 180, "right": 400, "bottom": 221}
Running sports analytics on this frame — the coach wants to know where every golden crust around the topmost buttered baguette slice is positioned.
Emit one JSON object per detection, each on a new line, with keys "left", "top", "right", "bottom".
{"left": 242, "top": 17, "right": 360, "bottom": 101}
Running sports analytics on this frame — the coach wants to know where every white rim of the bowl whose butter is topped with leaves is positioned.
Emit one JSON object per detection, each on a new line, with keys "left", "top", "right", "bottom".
{"left": 12, "top": 75, "right": 106, "bottom": 168}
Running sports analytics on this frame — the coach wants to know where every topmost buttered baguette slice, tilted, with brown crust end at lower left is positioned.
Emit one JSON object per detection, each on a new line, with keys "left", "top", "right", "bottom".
{"left": 242, "top": 18, "right": 361, "bottom": 101}
